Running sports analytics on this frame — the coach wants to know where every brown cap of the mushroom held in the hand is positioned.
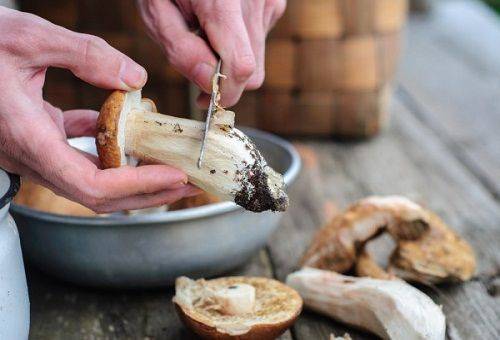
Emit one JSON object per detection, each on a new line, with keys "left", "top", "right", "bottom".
{"left": 96, "top": 90, "right": 143, "bottom": 169}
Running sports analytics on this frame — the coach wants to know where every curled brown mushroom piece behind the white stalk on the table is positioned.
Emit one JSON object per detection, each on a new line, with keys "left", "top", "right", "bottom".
{"left": 302, "top": 196, "right": 476, "bottom": 284}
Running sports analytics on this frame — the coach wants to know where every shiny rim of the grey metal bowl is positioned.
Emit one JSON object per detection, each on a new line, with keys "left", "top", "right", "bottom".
{"left": 10, "top": 127, "right": 302, "bottom": 226}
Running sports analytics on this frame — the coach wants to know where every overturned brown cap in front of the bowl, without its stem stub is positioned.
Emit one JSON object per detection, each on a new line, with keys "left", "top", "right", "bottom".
{"left": 173, "top": 276, "right": 302, "bottom": 340}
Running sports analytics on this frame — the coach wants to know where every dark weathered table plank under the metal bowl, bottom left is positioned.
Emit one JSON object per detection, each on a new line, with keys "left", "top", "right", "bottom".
{"left": 28, "top": 250, "right": 291, "bottom": 340}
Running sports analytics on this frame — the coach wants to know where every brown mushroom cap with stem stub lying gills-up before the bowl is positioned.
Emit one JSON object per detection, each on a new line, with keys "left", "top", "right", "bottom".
{"left": 173, "top": 276, "right": 302, "bottom": 340}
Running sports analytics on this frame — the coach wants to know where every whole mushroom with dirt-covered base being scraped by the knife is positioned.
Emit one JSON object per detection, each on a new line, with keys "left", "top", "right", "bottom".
{"left": 96, "top": 91, "right": 288, "bottom": 212}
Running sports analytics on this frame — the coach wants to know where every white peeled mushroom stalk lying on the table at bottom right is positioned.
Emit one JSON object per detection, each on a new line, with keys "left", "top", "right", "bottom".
{"left": 286, "top": 268, "right": 446, "bottom": 340}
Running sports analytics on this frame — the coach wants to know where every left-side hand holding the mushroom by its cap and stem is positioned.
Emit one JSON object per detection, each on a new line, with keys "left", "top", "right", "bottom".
{"left": 0, "top": 6, "right": 198, "bottom": 212}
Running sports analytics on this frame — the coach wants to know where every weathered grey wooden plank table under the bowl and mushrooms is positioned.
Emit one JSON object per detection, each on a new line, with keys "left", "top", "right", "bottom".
{"left": 28, "top": 1, "right": 500, "bottom": 340}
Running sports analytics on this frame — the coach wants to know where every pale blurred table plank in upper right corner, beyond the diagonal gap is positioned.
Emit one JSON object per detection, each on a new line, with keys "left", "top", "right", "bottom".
{"left": 399, "top": 0, "right": 500, "bottom": 199}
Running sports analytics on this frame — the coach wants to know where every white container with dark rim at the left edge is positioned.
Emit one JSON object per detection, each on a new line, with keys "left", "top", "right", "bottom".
{"left": 0, "top": 169, "right": 30, "bottom": 340}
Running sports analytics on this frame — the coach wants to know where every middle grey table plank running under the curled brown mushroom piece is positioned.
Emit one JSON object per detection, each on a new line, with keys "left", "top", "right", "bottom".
{"left": 269, "top": 96, "right": 500, "bottom": 339}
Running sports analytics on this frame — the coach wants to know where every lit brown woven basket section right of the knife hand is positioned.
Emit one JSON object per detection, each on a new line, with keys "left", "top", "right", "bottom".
{"left": 235, "top": 0, "right": 407, "bottom": 137}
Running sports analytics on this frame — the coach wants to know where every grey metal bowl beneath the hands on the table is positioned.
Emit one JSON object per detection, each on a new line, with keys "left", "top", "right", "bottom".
{"left": 11, "top": 129, "right": 300, "bottom": 288}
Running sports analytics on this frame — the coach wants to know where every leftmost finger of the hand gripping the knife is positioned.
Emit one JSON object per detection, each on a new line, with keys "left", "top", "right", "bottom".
{"left": 140, "top": 1, "right": 217, "bottom": 92}
